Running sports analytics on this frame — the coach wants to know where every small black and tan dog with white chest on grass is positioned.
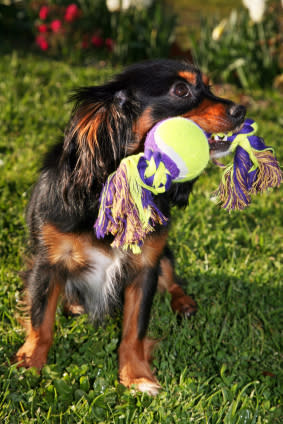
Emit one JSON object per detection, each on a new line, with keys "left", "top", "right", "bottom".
{"left": 15, "top": 60, "right": 246, "bottom": 395}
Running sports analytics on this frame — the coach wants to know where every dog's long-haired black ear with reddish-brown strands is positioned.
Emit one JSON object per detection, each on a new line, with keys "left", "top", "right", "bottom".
{"left": 64, "top": 83, "right": 138, "bottom": 188}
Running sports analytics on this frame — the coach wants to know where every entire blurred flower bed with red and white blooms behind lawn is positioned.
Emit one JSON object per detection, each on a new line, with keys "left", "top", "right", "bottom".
{"left": 0, "top": 0, "right": 283, "bottom": 89}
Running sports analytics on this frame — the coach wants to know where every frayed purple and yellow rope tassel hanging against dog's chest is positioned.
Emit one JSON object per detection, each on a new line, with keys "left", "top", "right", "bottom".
{"left": 94, "top": 155, "right": 167, "bottom": 253}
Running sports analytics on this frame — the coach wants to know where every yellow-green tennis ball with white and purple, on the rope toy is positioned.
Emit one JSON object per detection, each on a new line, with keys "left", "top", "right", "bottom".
{"left": 145, "top": 116, "right": 209, "bottom": 182}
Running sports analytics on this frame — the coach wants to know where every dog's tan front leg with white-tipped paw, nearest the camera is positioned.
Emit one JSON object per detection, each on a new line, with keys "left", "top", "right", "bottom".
{"left": 119, "top": 267, "right": 160, "bottom": 395}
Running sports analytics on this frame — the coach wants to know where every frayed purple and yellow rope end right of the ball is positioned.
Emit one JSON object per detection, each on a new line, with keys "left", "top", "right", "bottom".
{"left": 210, "top": 119, "right": 282, "bottom": 211}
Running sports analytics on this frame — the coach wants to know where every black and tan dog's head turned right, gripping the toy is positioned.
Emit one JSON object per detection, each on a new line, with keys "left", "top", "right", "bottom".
{"left": 65, "top": 60, "right": 245, "bottom": 187}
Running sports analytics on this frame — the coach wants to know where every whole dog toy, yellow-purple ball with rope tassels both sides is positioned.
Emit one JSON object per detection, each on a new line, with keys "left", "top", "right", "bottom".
{"left": 94, "top": 117, "right": 282, "bottom": 253}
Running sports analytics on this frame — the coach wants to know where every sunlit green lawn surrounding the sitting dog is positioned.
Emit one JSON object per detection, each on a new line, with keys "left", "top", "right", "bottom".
{"left": 0, "top": 54, "right": 283, "bottom": 424}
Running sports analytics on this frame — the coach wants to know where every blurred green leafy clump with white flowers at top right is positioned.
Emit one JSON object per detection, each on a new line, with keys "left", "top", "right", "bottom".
{"left": 192, "top": 0, "right": 283, "bottom": 88}
